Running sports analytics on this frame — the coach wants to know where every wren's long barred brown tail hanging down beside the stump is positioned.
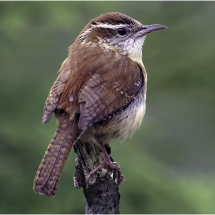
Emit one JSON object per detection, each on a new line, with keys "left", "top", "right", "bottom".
{"left": 33, "top": 116, "right": 78, "bottom": 197}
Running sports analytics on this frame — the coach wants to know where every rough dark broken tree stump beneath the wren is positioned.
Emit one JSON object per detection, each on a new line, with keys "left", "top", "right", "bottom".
{"left": 74, "top": 141, "right": 125, "bottom": 214}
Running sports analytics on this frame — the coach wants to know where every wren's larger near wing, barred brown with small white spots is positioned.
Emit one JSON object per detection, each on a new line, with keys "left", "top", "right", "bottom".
{"left": 78, "top": 58, "right": 144, "bottom": 130}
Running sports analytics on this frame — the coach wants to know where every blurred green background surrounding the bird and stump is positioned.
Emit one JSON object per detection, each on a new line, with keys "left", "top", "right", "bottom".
{"left": 0, "top": 2, "right": 215, "bottom": 213}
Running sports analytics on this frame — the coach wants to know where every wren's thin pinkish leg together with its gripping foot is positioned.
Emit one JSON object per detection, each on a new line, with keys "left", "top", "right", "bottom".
{"left": 87, "top": 139, "right": 121, "bottom": 183}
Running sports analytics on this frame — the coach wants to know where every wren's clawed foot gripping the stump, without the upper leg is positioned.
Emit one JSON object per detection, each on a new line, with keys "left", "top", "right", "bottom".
{"left": 87, "top": 156, "right": 121, "bottom": 184}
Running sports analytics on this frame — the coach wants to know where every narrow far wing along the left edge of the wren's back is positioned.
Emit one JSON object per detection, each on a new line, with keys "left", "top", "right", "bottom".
{"left": 42, "top": 59, "right": 71, "bottom": 124}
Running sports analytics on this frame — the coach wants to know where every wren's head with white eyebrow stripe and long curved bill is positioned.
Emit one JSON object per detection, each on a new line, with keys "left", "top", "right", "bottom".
{"left": 77, "top": 12, "right": 167, "bottom": 60}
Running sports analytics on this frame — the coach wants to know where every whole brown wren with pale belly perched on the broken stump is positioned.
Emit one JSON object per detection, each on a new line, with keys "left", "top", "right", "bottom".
{"left": 33, "top": 12, "right": 167, "bottom": 196}
